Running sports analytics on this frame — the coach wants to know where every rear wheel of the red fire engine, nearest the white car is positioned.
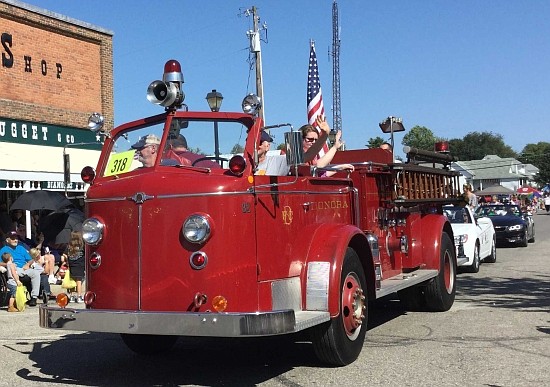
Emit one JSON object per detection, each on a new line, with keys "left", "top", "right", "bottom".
{"left": 425, "top": 233, "right": 456, "bottom": 312}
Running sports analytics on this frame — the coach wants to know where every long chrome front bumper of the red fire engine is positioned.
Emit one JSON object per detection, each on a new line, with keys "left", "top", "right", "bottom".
{"left": 39, "top": 305, "right": 330, "bottom": 337}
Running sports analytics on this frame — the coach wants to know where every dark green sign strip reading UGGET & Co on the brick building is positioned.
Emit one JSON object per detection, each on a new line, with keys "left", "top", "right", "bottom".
{"left": 0, "top": 117, "right": 102, "bottom": 150}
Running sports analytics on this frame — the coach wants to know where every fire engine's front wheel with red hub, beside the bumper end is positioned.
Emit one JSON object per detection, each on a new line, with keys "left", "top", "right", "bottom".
{"left": 311, "top": 248, "right": 368, "bottom": 366}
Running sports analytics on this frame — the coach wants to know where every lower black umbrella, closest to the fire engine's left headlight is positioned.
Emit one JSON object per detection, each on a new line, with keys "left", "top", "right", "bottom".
{"left": 38, "top": 208, "right": 84, "bottom": 244}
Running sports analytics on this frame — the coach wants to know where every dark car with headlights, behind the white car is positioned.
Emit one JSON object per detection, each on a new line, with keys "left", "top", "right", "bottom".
{"left": 476, "top": 204, "right": 535, "bottom": 247}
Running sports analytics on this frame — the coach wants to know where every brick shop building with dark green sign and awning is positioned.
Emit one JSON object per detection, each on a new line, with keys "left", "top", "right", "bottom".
{"left": 0, "top": 0, "right": 114, "bottom": 212}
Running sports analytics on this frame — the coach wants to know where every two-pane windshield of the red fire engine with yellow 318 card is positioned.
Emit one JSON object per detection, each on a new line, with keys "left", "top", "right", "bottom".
{"left": 103, "top": 118, "right": 247, "bottom": 176}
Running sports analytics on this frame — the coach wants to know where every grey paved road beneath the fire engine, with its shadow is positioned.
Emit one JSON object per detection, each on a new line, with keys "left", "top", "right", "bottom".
{"left": 0, "top": 214, "right": 550, "bottom": 387}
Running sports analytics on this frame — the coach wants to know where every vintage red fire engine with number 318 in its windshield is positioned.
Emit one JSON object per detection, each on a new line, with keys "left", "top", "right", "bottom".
{"left": 40, "top": 60, "right": 459, "bottom": 365}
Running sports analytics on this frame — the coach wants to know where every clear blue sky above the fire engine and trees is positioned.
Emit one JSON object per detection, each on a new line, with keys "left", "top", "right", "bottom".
{"left": 19, "top": 0, "right": 550, "bottom": 157}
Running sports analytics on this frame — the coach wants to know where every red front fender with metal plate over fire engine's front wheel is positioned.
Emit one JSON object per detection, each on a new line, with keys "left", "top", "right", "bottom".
{"left": 301, "top": 224, "right": 374, "bottom": 317}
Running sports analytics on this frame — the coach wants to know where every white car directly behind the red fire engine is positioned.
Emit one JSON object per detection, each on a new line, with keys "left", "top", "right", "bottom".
{"left": 443, "top": 206, "right": 497, "bottom": 273}
